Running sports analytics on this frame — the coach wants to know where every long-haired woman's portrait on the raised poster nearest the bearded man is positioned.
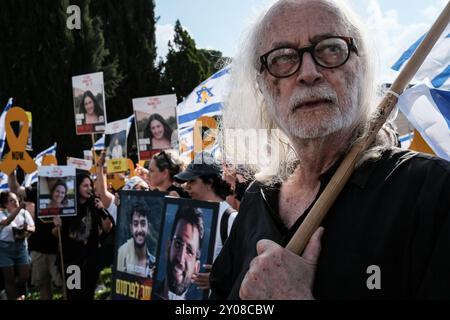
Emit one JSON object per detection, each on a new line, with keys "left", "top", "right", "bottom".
{"left": 144, "top": 113, "right": 172, "bottom": 149}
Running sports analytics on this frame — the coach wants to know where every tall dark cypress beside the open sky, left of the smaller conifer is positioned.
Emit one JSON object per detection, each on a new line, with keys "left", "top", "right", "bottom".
{"left": 91, "top": 0, "right": 159, "bottom": 120}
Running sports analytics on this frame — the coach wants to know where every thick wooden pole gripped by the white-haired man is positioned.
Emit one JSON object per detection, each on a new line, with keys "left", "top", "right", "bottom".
{"left": 286, "top": 2, "right": 450, "bottom": 254}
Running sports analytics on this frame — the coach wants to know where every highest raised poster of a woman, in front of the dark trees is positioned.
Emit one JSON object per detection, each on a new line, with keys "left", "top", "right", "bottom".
{"left": 72, "top": 72, "right": 106, "bottom": 135}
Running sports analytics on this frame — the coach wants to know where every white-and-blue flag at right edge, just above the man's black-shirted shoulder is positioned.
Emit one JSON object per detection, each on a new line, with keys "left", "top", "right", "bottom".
{"left": 398, "top": 83, "right": 450, "bottom": 161}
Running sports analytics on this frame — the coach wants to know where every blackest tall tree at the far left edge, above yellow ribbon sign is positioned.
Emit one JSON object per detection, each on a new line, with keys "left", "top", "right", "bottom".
{"left": 0, "top": 0, "right": 74, "bottom": 160}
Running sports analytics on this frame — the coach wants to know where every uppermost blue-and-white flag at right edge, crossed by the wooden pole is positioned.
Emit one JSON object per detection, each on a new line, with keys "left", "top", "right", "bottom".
{"left": 391, "top": 25, "right": 450, "bottom": 89}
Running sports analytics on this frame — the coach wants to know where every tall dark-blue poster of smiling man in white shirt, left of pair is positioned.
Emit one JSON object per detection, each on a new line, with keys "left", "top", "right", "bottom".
{"left": 112, "top": 190, "right": 166, "bottom": 300}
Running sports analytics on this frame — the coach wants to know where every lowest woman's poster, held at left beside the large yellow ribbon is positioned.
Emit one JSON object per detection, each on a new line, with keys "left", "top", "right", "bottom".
{"left": 38, "top": 166, "right": 77, "bottom": 218}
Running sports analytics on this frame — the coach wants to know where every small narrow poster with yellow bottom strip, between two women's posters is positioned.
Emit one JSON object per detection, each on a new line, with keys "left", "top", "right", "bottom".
{"left": 105, "top": 119, "right": 128, "bottom": 173}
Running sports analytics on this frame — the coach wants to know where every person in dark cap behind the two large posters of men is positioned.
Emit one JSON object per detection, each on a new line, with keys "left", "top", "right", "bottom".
{"left": 174, "top": 153, "right": 237, "bottom": 289}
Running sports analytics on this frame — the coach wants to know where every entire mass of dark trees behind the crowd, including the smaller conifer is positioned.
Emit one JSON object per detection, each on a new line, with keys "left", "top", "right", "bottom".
{"left": 0, "top": 0, "right": 222, "bottom": 163}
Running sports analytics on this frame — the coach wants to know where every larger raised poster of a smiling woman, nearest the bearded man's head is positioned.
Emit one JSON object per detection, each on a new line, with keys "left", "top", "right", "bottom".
{"left": 133, "top": 94, "right": 178, "bottom": 160}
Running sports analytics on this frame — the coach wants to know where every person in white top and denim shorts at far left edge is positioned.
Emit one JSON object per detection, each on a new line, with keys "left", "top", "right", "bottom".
{"left": 0, "top": 191, "right": 35, "bottom": 300}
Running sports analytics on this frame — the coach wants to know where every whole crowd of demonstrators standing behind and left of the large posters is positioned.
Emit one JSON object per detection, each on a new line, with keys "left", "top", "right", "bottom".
{"left": 0, "top": 147, "right": 251, "bottom": 300}
